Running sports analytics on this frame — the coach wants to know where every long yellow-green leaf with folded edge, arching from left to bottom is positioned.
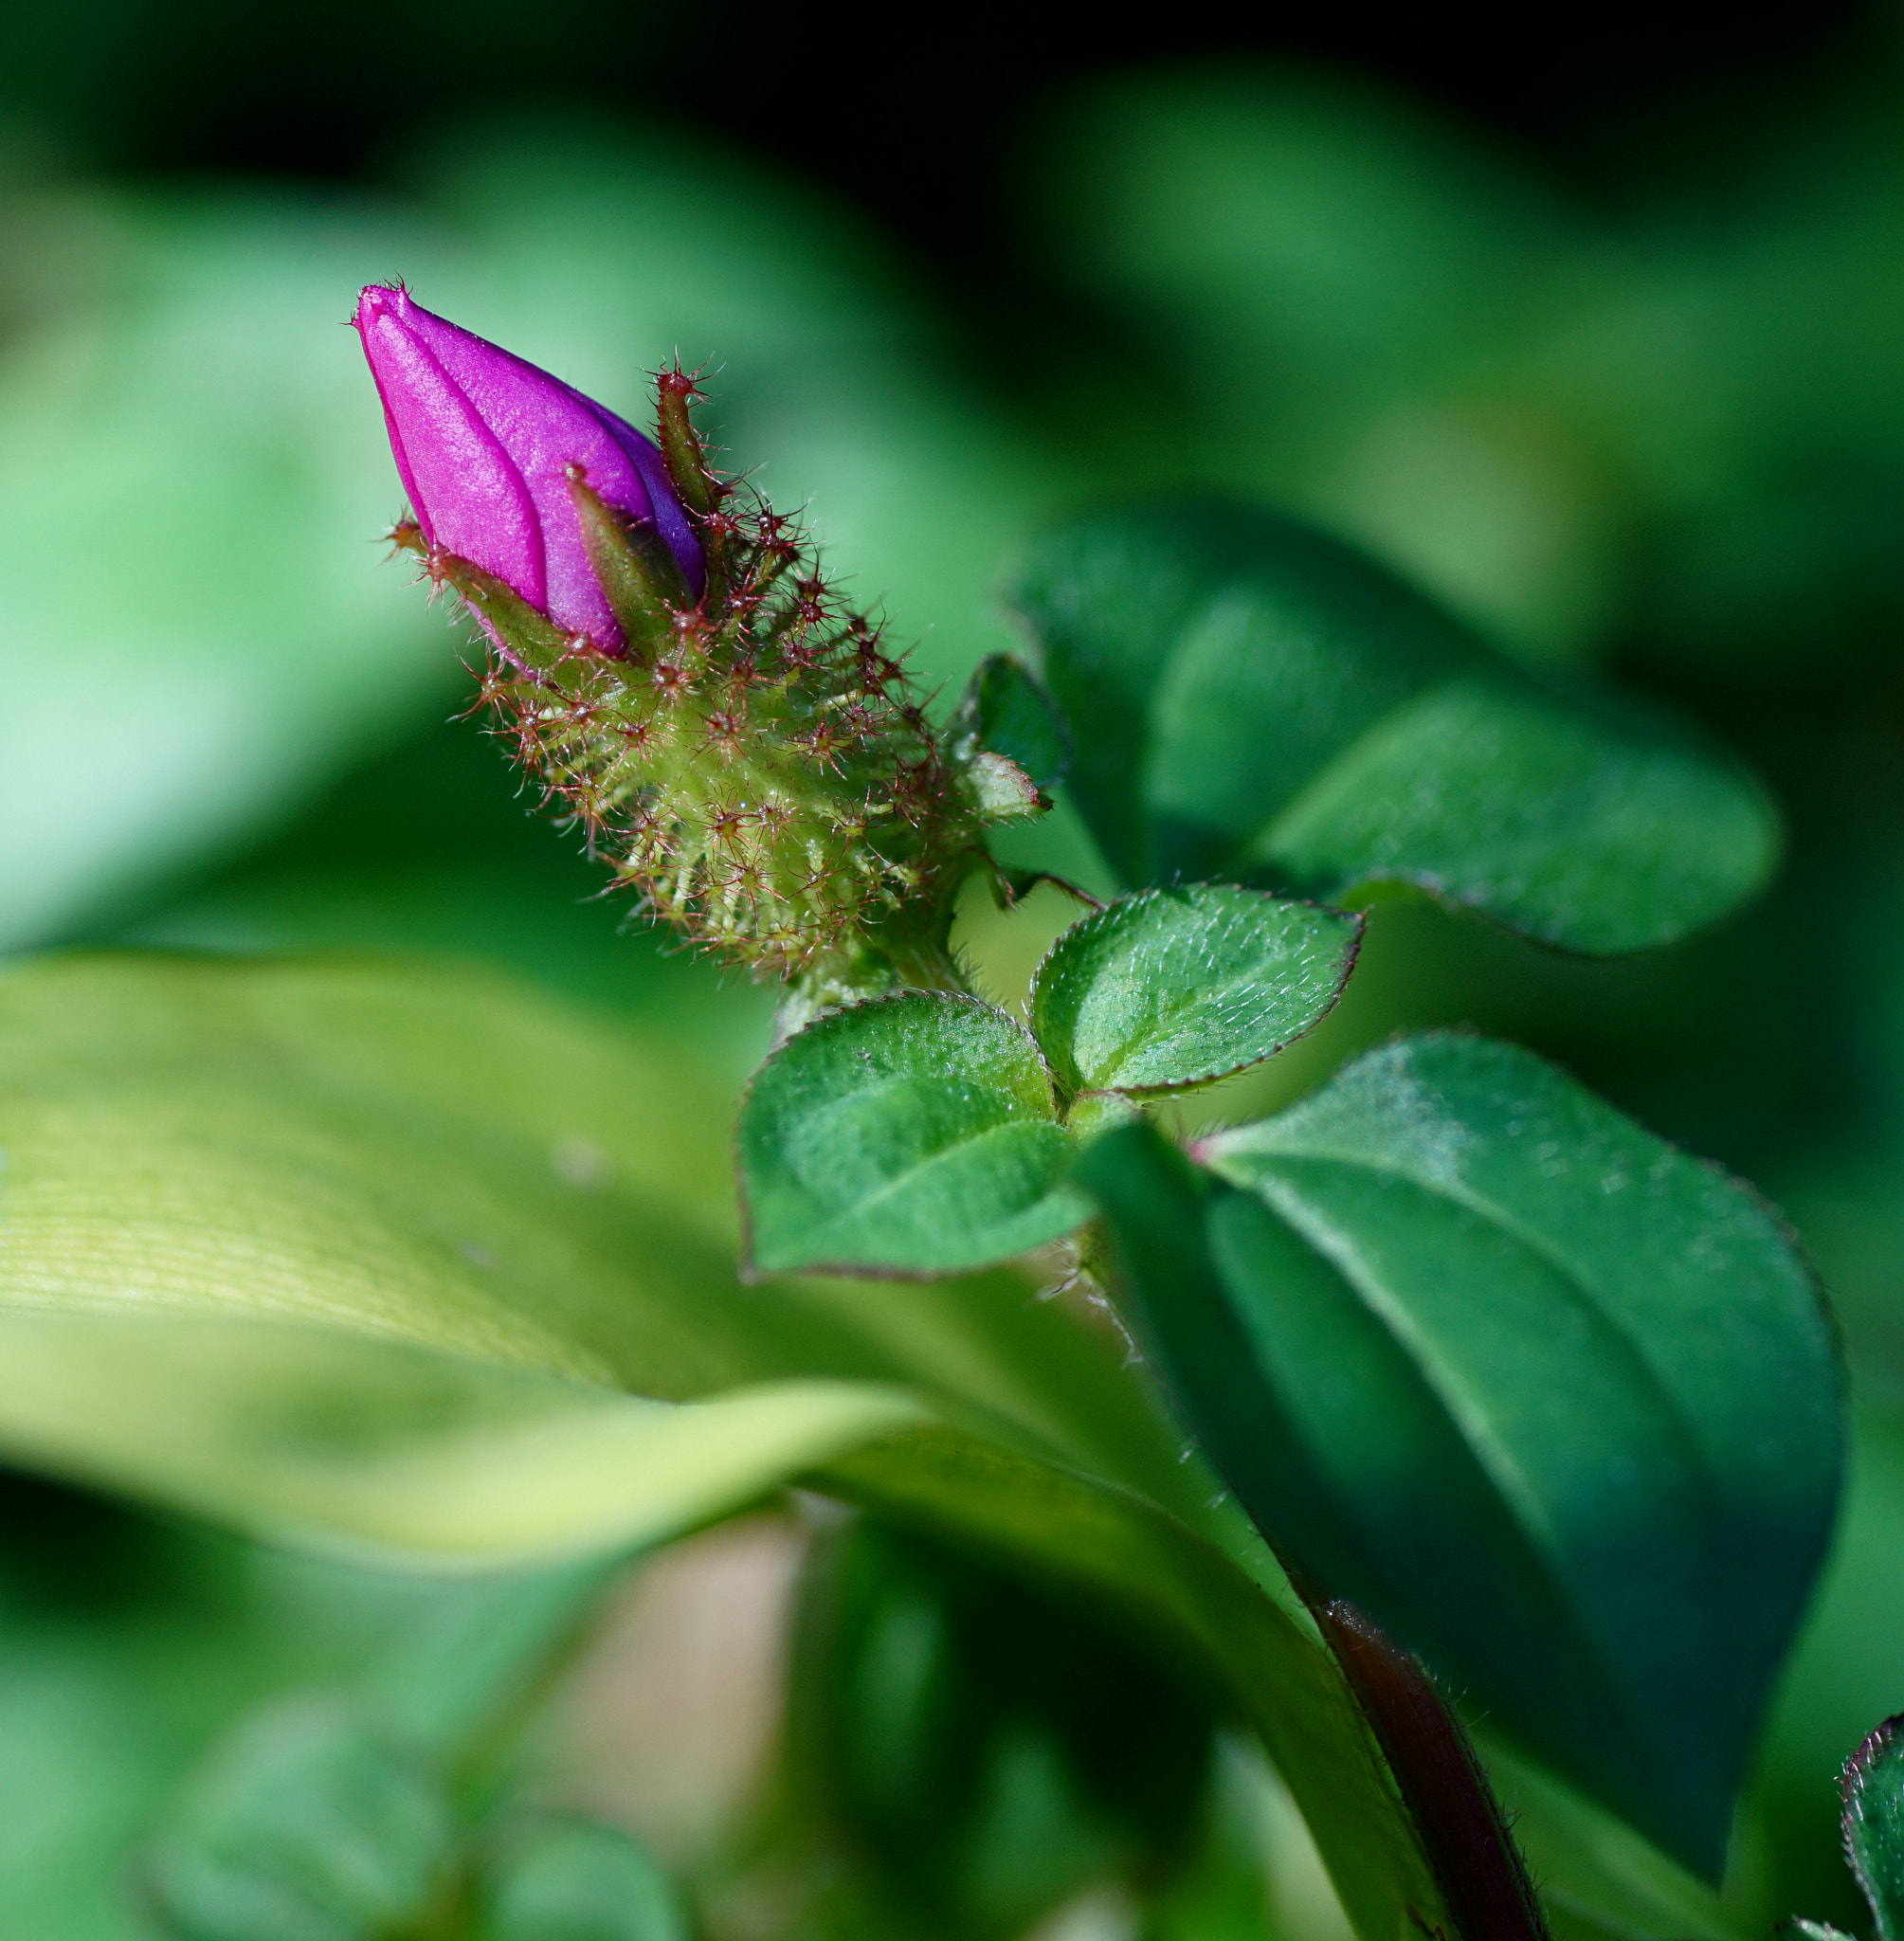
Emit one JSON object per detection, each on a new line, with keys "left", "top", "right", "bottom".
{"left": 0, "top": 957, "right": 1731, "bottom": 1941}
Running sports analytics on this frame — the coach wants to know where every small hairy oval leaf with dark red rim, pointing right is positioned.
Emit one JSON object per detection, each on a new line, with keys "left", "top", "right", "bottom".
{"left": 1030, "top": 883, "right": 1363, "bottom": 1093}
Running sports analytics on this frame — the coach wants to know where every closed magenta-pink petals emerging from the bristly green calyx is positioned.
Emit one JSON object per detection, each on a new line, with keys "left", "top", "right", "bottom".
{"left": 355, "top": 283, "right": 704, "bottom": 650}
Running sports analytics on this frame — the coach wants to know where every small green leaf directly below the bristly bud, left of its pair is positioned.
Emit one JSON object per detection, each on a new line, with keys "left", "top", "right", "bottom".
{"left": 737, "top": 992, "right": 1085, "bottom": 1273}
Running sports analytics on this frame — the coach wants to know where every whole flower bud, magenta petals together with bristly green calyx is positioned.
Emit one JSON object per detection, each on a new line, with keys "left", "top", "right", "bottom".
{"left": 357, "top": 299, "right": 1044, "bottom": 1019}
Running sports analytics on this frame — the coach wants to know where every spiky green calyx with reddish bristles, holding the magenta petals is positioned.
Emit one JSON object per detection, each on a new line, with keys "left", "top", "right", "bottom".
{"left": 392, "top": 372, "right": 1043, "bottom": 1013}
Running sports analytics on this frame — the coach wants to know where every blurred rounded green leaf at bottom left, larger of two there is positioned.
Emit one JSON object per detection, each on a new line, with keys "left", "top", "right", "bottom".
{"left": 139, "top": 1698, "right": 456, "bottom": 1941}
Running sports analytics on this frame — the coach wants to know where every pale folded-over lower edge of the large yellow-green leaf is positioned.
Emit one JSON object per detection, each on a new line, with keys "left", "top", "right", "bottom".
{"left": 0, "top": 1308, "right": 922, "bottom": 1569}
